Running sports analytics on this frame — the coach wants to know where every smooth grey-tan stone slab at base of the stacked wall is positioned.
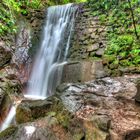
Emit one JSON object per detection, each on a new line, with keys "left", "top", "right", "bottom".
{"left": 62, "top": 60, "right": 106, "bottom": 83}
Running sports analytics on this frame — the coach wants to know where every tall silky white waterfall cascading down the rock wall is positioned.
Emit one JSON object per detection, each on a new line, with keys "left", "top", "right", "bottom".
{"left": 25, "top": 4, "right": 77, "bottom": 97}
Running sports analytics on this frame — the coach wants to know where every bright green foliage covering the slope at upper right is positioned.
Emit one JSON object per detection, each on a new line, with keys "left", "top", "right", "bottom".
{"left": 88, "top": 0, "right": 140, "bottom": 67}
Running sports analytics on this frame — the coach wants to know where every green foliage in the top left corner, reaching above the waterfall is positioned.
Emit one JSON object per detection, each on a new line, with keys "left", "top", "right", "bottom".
{"left": 0, "top": 0, "right": 85, "bottom": 36}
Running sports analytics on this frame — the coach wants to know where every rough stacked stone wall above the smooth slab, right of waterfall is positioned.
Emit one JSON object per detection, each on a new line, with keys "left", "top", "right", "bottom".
{"left": 69, "top": 4, "right": 107, "bottom": 60}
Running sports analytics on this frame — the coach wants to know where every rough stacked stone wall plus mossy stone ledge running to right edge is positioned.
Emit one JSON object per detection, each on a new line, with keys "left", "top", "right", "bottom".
{"left": 65, "top": 3, "right": 140, "bottom": 79}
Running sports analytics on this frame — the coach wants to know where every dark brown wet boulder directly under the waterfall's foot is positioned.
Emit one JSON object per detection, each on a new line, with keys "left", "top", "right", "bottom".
{"left": 16, "top": 100, "right": 52, "bottom": 124}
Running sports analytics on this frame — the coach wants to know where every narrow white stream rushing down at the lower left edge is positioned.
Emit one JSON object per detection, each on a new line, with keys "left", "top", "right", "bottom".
{"left": 0, "top": 105, "right": 16, "bottom": 131}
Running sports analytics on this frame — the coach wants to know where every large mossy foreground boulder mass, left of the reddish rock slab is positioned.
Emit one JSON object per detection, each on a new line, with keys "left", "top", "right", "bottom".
{"left": 0, "top": 96, "right": 110, "bottom": 140}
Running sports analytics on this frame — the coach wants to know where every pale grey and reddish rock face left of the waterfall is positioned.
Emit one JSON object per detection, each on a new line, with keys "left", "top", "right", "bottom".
{"left": 11, "top": 23, "right": 31, "bottom": 84}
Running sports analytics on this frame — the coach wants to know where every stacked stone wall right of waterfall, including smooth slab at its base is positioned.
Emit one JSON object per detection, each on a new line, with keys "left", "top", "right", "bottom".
{"left": 62, "top": 4, "right": 107, "bottom": 82}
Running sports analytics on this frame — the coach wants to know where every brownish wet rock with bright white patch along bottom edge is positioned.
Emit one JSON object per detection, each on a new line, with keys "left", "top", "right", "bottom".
{"left": 0, "top": 116, "right": 85, "bottom": 140}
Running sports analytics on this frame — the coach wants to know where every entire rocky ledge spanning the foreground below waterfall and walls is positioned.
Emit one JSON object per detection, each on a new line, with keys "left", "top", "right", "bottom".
{"left": 0, "top": 75, "right": 140, "bottom": 140}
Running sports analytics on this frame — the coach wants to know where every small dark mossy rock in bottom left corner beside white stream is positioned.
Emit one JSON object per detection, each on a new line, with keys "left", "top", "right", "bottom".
{"left": 0, "top": 126, "right": 17, "bottom": 140}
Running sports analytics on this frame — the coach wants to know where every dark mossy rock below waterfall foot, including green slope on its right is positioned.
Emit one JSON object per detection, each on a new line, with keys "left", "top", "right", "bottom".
{"left": 16, "top": 97, "right": 70, "bottom": 126}
